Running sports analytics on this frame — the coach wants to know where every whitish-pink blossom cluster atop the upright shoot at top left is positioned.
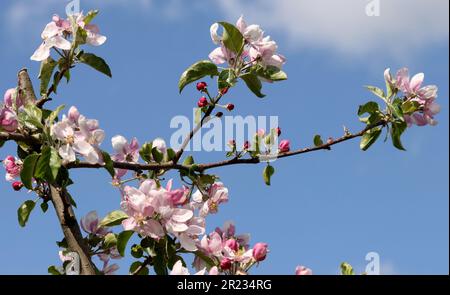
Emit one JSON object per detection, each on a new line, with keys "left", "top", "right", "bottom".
{"left": 31, "top": 13, "right": 106, "bottom": 61}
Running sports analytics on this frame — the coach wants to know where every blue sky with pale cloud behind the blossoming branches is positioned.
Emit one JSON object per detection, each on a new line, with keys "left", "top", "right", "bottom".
{"left": 0, "top": 0, "right": 449, "bottom": 274}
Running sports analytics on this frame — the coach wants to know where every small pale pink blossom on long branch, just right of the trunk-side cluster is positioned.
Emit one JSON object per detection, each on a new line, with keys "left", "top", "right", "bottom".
{"left": 111, "top": 135, "right": 139, "bottom": 178}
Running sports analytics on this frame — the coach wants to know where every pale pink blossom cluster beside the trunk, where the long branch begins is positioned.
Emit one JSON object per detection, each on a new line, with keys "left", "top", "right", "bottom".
{"left": 50, "top": 107, "right": 105, "bottom": 164}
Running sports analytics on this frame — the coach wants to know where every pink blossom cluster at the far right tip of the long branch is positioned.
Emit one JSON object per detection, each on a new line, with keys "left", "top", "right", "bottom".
{"left": 384, "top": 68, "right": 440, "bottom": 126}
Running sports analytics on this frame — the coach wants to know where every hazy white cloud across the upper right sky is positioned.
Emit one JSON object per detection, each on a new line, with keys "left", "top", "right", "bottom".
{"left": 217, "top": 0, "right": 449, "bottom": 56}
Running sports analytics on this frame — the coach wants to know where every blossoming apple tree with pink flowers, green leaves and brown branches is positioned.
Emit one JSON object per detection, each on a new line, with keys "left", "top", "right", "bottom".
{"left": 0, "top": 11, "right": 439, "bottom": 275}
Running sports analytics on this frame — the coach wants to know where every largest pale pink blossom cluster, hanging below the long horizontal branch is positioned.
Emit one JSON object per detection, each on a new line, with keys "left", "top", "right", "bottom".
{"left": 121, "top": 179, "right": 228, "bottom": 251}
